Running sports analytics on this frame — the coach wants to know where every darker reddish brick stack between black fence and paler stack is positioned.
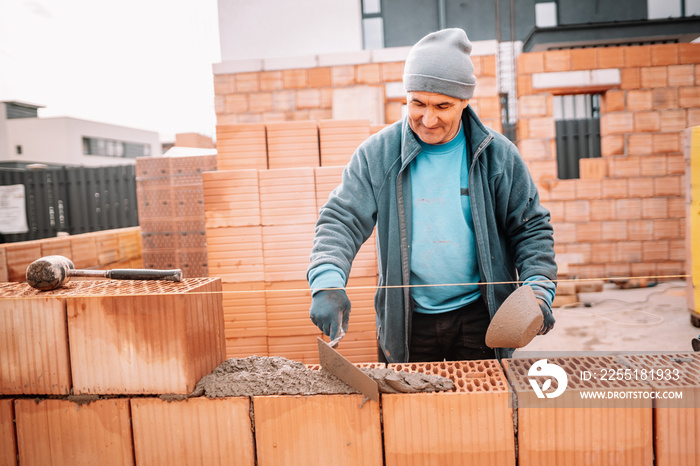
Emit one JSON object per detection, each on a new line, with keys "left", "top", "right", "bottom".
{"left": 136, "top": 155, "right": 216, "bottom": 278}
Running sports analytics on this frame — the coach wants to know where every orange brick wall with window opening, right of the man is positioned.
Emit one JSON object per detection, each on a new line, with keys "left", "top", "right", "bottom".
{"left": 516, "top": 43, "right": 700, "bottom": 278}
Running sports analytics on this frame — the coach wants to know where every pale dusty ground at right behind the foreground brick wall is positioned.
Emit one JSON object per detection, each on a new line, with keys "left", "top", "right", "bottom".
{"left": 513, "top": 280, "right": 700, "bottom": 357}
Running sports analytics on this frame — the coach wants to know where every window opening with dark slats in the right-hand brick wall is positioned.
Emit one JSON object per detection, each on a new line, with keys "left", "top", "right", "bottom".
{"left": 554, "top": 94, "right": 601, "bottom": 180}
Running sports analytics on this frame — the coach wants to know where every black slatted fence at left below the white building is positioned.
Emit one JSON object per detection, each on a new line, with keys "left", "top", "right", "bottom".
{"left": 0, "top": 165, "right": 138, "bottom": 242}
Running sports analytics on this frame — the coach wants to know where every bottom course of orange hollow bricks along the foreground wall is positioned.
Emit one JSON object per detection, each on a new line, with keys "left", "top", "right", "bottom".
{"left": 0, "top": 353, "right": 700, "bottom": 466}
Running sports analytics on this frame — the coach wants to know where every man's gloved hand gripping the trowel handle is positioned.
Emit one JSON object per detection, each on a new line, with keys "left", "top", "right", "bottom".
{"left": 309, "top": 289, "right": 350, "bottom": 346}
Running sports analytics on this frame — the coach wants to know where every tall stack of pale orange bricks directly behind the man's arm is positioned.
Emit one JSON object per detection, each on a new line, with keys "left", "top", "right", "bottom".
{"left": 209, "top": 120, "right": 377, "bottom": 363}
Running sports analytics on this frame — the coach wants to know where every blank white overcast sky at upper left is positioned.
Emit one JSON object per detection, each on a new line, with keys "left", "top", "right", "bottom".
{"left": 0, "top": 0, "right": 221, "bottom": 142}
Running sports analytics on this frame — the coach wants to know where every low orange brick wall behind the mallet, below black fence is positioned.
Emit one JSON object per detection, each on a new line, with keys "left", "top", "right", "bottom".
{"left": 0, "top": 227, "right": 143, "bottom": 283}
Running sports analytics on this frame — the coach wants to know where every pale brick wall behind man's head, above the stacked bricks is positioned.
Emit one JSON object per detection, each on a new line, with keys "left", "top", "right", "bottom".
{"left": 214, "top": 46, "right": 501, "bottom": 131}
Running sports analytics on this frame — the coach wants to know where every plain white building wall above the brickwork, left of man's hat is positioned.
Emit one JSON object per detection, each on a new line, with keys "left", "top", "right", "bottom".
{"left": 218, "top": 0, "right": 362, "bottom": 62}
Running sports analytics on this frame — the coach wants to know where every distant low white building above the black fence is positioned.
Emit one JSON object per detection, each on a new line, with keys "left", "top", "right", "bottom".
{"left": 5, "top": 117, "right": 162, "bottom": 166}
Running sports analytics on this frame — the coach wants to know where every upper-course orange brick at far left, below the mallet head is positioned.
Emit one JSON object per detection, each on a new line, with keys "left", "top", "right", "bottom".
{"left": 0, "top": 294, "right": 72, "bottom": 395}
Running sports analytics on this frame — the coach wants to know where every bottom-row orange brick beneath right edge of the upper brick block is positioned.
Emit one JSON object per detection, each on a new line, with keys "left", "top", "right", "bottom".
{"left": 131, "top": 397, "right": 255, "bottom": 466}
